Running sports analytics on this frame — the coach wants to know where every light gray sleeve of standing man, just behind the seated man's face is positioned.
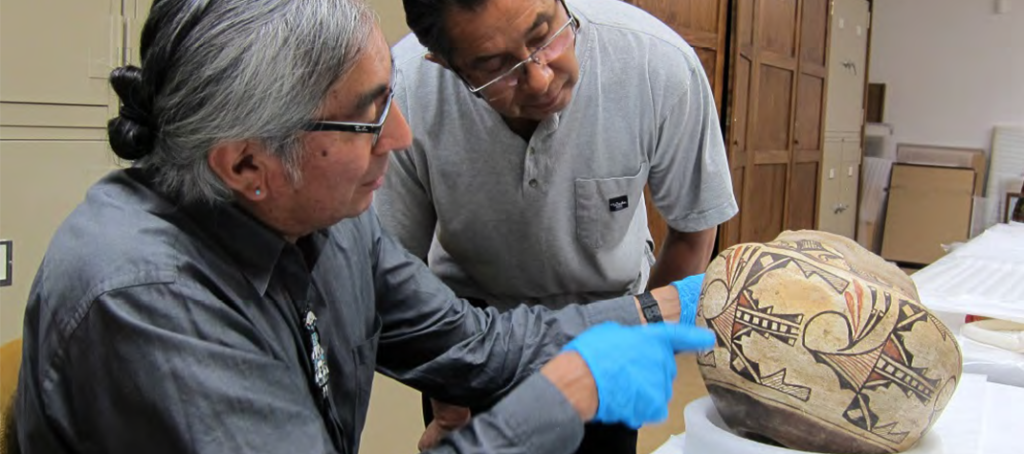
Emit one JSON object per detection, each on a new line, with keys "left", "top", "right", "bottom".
{"left": 374, "top": 71, "right": 437, "bottom": 260}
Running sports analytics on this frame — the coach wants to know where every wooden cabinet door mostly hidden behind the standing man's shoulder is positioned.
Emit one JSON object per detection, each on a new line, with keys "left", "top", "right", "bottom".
{"left": 625, "top": 0, "right": 729, "bottom": 253}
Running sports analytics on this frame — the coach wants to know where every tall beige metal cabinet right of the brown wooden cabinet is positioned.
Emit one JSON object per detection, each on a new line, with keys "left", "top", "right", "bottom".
{"left": 818, "top": 0, "right": 870, "bottom": 239}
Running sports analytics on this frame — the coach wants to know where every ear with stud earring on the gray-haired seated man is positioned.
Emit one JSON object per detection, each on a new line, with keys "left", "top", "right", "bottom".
{"left": 207, "top": 140, "right": 272, "bottom": 202}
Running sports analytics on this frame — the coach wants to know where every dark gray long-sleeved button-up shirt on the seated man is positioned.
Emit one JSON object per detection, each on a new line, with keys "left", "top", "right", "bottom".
{"left": 16, "top": 169, "right": 639, "bottom": 454}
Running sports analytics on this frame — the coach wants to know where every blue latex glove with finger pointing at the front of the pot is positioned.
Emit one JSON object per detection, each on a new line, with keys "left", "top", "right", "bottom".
{"left": 563, "top": 323, "right": 715, "bottom": 428}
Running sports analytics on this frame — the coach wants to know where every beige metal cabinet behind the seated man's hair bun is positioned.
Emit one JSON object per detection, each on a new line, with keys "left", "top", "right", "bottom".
{"left": 0, "top": 0, "right": 150, "bottom": 342}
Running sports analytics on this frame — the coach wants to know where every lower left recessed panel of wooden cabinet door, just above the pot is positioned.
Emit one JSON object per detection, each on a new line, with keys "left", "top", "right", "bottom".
{"left": 740, "top": 164, "right": 787, "bottom": 243}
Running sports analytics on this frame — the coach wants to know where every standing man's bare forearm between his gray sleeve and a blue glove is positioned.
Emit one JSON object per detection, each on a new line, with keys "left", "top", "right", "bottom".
{"left": 647, "top": 228, "right": 718, "bottom": 289}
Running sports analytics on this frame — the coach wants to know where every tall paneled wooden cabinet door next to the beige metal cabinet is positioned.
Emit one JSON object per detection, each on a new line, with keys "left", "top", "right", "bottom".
{"left": 723, "top": 0, "right": 829, "bottom": 247}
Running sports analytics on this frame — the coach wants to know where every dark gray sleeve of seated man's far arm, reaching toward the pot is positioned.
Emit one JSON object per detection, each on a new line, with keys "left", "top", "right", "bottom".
{"left": 374, "top": 208, "right": 640, "bottom": 410}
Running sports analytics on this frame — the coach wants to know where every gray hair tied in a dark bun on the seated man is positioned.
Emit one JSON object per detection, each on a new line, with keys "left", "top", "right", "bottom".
{"left": 108, "top": 0, "right": 375, "bottom": 203}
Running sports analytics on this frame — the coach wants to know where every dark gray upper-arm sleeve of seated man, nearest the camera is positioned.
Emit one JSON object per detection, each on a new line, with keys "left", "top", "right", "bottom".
{"left": 38, "top": 284, "right": 336, "bottom": 454}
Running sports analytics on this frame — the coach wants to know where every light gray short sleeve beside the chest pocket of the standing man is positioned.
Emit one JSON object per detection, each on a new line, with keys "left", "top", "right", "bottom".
{"left": 648, "top": 47, "right": 738, "bottom": 232}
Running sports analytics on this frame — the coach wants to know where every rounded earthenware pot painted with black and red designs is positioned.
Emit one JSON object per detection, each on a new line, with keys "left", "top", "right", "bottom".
{"left": 696, "top": 231, "right": 963, "bottom": 454}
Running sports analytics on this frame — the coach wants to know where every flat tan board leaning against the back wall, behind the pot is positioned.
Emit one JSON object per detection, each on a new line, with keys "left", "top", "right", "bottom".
{"left": 882, "top": 164, "right": 975, "bottom": 264}
